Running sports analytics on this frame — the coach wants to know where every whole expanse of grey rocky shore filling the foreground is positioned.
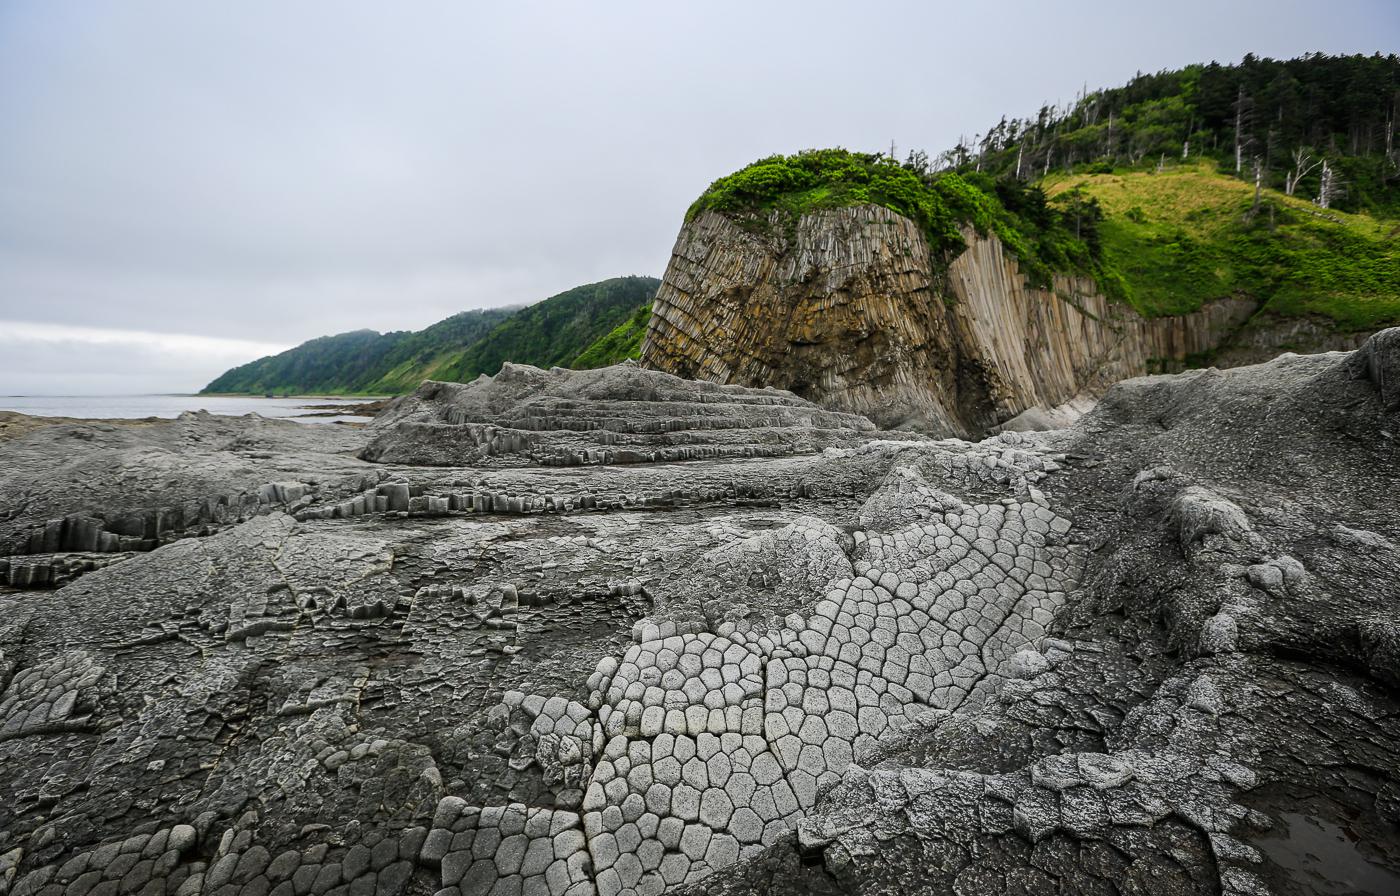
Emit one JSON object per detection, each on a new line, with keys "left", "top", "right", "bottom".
{"left": 0, "top": 337, "right": 1400, "bottom": 896}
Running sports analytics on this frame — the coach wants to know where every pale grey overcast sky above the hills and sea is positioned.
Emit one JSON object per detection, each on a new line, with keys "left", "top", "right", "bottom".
{"left": 0, "top": 0, "right": 1400, "bottom": 395}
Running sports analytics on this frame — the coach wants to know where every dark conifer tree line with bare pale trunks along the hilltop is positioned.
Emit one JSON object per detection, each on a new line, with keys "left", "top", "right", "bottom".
{"left": 903, "top": 53, "right": 1400, "bottom": 214}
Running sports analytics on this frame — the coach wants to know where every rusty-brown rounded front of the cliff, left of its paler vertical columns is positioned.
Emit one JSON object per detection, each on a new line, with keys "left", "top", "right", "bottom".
{"left": 641, "top": 206, "right": 956, "bottom": 427}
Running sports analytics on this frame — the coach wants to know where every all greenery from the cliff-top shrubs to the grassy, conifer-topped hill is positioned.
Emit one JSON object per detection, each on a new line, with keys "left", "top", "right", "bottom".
{"left": 689, "top": 55, "right": 1400, "bottom": 330}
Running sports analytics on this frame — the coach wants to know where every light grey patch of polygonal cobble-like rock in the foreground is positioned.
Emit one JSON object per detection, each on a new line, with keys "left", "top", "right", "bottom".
{"left": 459, "top": 468, "right": 1077, "bottom": 896}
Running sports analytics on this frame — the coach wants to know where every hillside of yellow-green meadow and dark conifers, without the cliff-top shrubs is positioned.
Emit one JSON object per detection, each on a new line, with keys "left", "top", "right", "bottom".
{"left": 935, "top": 53, "right": 1400, "bottom": 330}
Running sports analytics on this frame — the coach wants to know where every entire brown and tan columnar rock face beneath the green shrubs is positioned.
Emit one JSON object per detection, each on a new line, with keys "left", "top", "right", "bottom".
{"left": 641, "top": 206, "right": 1254, "bottom": 435}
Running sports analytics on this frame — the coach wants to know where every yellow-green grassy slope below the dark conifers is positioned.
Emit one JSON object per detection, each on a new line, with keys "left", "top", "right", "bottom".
{"left": 1044, "top": 161, "right": 1400, "bottom": 329}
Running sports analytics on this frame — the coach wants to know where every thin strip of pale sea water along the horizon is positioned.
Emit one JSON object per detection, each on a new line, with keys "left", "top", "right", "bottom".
{"left": 0, "top": 395, "right": 368, "bottom": 423}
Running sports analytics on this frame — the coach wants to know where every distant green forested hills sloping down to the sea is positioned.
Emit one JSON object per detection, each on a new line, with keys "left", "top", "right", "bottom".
{"left": 204, "top": 277, "right": 659, "bottom": 395}
